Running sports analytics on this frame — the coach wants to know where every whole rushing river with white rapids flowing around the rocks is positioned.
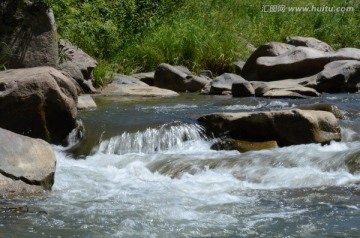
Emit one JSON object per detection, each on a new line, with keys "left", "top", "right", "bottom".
{"left": 0, "top": 94, "right": 360, "bottom": 237}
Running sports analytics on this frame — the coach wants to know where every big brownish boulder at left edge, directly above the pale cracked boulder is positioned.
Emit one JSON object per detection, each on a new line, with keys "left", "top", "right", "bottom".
{"left": 0, "top": 67, "right": 77, "bottom": 144}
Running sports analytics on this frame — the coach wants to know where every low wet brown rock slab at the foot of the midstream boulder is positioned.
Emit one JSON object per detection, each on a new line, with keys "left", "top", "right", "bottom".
{"left": 210, "top": 138, "right": 278, "bottom": 153}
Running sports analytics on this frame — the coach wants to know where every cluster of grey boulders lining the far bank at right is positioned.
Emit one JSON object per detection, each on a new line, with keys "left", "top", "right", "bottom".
{"left": 133, "top": 37, "right": 360, "bottom": 98}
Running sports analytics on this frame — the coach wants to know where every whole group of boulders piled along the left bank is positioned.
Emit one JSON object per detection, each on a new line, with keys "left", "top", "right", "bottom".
{"left": 0, "top": 0, "right": 97, "bottom": 196}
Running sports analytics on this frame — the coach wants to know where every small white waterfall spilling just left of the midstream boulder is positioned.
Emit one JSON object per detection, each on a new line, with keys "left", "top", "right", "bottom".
{"left": 98, "top": 122, "right": 206, "bottom": 155}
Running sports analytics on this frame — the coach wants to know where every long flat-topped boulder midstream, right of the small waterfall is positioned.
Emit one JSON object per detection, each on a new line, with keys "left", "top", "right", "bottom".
{"left": 198, "top": 109, "right": 341, "bottom": 146}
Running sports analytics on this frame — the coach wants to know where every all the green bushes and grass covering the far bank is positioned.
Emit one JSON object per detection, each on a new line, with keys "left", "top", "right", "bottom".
{"left": 46, "top": 0, "right": 360, "bottom": 85}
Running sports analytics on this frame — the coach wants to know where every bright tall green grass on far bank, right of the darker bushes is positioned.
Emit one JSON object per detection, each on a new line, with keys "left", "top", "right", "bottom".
{"left": 115, "top": 0, "right": 360, "bottom": 74}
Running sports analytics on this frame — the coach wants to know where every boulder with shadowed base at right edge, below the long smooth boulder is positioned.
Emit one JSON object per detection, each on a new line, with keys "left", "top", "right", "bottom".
{"left": 308, "top": 60, "right": 360, "bottom": 93}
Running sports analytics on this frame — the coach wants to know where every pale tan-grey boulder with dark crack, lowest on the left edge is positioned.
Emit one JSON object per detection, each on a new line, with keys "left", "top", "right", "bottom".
{"left": 0, "top": 128, "right": 56, "bottom": 199}
